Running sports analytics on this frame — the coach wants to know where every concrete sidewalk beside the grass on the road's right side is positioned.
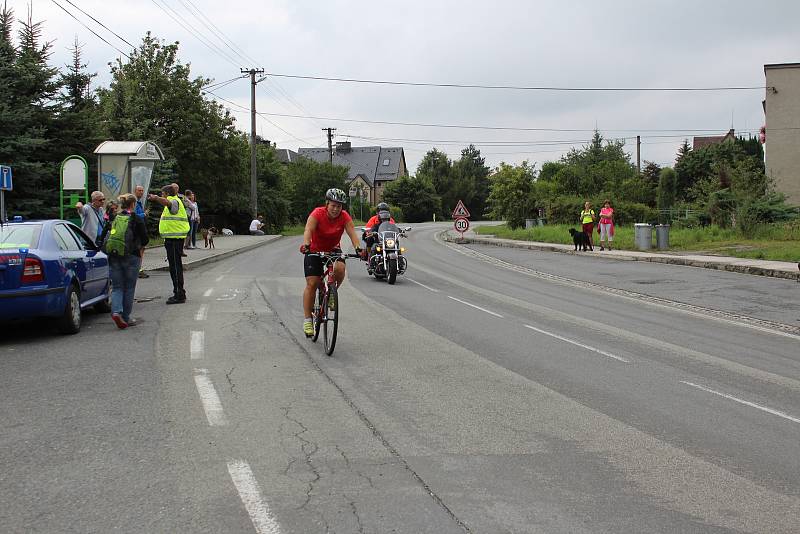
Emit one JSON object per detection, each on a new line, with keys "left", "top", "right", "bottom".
{"left": 444, "top": 230, "right": 800, "bottom": 281}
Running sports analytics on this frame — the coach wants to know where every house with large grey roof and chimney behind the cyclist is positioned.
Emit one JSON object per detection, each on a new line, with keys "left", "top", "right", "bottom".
{"left": 297, "top": 141, "right": 408, "bottom": 204}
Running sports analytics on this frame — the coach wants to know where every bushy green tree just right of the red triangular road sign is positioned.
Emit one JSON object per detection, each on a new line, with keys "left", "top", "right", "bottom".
{"left": 488, "top": 161, "right": 536, "bottom": 228}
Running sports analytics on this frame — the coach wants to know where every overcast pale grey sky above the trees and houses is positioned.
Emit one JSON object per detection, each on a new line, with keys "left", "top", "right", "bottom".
{"left": 6, "top": 0, "right": 800, "bottom": 173}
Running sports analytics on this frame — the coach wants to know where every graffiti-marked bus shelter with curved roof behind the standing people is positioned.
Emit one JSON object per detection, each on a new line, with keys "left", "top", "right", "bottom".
{"left": 94, "top": 141, "right": 164, "bottom": 199}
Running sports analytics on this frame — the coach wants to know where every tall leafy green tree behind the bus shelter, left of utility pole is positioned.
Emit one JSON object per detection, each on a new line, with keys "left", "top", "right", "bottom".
{"left": 99, "top": 32, "right": 250, "bottom": 225}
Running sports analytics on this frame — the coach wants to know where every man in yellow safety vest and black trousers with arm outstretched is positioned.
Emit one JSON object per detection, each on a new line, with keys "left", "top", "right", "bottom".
{"left": 147, "top": 184, "right": 189, "bottom": 304}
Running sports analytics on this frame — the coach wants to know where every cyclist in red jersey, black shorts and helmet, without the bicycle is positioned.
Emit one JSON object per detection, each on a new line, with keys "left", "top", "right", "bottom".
{"left": 300, "top": 188, "right": 361, "bottom": 336}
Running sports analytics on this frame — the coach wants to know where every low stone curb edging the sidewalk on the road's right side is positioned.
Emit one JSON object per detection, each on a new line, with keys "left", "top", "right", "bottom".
{"left": 440, "top": 234, "right": 800, "bottom": 281}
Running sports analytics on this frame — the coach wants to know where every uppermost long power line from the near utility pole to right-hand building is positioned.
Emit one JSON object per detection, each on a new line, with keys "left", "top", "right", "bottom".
{"left": 266, "top": 72, "right": 767, "bottom": 92}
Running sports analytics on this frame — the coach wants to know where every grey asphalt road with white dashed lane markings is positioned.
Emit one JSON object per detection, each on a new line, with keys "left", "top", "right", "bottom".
{"left": 0, "top": 224, "right": 800, "bottom": 533}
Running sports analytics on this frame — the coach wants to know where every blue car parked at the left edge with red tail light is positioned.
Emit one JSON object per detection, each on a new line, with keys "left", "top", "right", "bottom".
{"left": 0, "top": 218, "right": 111, "bottom": 334}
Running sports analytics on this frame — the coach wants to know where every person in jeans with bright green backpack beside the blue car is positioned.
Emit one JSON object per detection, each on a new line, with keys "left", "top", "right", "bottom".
{"left": 100, "top": 194, "right": 150, "bottom": 330}
